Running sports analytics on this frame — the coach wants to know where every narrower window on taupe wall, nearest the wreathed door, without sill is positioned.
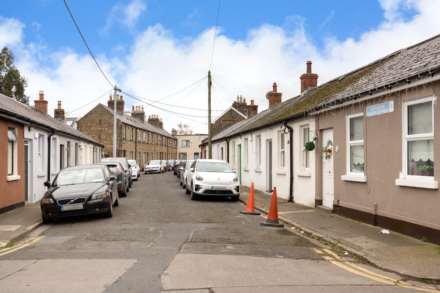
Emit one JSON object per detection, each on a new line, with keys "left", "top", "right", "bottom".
{"left": 346, "top": 114, "right": 365, "bottom": 176}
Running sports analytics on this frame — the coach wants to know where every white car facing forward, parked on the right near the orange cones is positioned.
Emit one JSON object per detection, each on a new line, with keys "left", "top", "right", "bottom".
{"left": 186, "top": 160, "right": 240, "bottom": 200}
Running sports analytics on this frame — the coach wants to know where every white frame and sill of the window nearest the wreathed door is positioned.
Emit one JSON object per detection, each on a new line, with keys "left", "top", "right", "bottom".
{"left": 341, "top": 112, "right": 367, "bottom": 182}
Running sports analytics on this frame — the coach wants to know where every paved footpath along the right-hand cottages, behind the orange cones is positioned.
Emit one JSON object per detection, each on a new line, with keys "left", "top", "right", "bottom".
{"left": 240, "top": 186, "right": 440, "bottom": 282}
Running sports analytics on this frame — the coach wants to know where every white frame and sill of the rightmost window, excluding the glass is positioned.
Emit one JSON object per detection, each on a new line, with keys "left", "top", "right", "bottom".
{"left": 396, "top": 97, "right": 438, "bottom": 189}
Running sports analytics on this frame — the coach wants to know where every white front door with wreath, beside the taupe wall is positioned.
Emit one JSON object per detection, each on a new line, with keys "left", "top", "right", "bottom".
{"left": 321, "top": 129, "right": 335, "bottom": 209}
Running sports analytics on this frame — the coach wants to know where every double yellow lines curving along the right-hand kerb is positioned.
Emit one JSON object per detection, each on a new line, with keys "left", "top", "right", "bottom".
{"left": 315, "top": 248, "right": 440, "bottom": 293}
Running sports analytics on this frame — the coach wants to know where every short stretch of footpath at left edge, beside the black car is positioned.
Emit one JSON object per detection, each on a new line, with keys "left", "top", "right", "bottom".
{"left": 0, "top": 203, "right": 41, "bottom": 249}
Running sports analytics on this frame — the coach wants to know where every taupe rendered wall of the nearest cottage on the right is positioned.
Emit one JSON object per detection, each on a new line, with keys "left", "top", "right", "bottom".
{"left": 317, "top": 82, "right": 440, "bottom": 242}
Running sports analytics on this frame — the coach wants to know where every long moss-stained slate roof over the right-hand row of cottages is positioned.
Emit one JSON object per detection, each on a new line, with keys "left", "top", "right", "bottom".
{"left": 213, "top": 35, "right": 440, "bottom": 141}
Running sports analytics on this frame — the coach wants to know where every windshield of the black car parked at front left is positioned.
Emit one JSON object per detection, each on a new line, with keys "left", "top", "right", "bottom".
{"left": 54, "top": 168, "right": 105, "bottom": 186}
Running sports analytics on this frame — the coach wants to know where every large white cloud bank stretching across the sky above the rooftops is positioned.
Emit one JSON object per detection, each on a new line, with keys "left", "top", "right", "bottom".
{"left": 0, "top": 0, "right": 440, "bottom": 132}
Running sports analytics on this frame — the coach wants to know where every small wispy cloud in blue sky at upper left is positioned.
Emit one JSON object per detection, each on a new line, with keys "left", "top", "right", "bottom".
{"left": 103, "top": 0, "right": 147, "bottom": 32}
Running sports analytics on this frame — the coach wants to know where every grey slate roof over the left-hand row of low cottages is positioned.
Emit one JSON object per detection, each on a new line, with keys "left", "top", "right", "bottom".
{"left": 0, "top": 94, "right": 103, "bottom": 146}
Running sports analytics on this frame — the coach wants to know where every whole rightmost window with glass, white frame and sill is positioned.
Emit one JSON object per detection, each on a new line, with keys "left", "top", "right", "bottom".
{"left": 396, "top": 98, "right": 438, "bottom": 189}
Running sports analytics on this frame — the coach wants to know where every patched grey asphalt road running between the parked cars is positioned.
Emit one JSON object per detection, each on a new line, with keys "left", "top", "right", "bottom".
{"left": 0, "top": 174, "right": 428, "bottom": 293}
